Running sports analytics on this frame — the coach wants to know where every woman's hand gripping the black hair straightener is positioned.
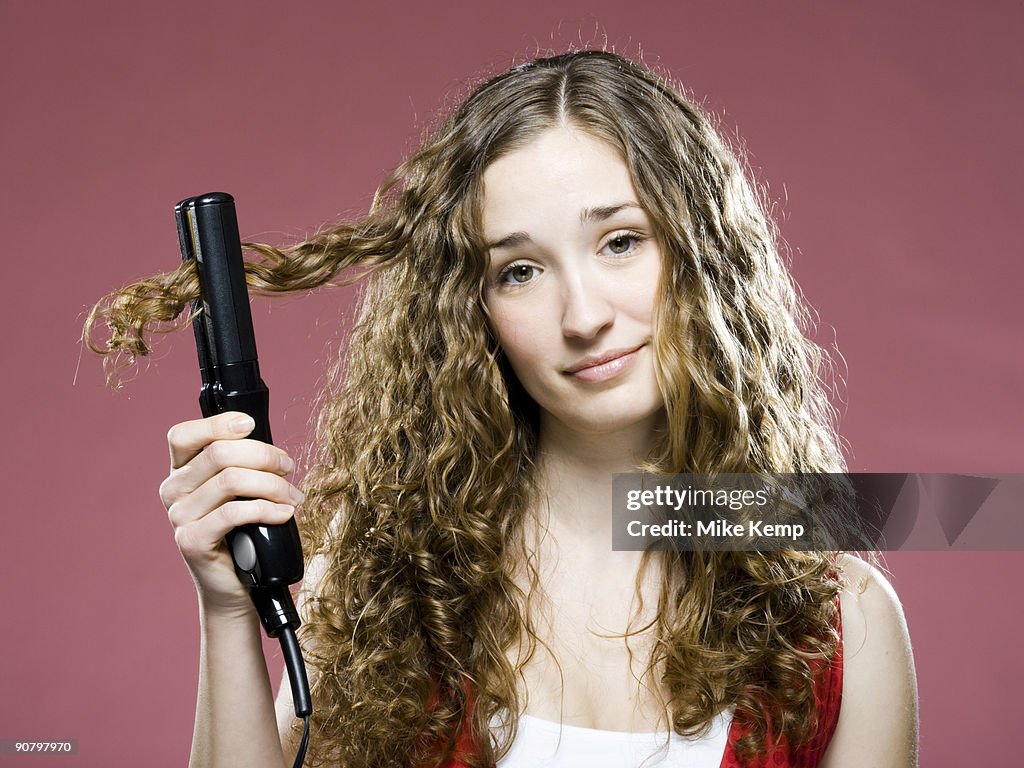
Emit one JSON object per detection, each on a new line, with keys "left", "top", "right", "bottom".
{"left": 160, "top": 411, "right": 302, "bottom": 616}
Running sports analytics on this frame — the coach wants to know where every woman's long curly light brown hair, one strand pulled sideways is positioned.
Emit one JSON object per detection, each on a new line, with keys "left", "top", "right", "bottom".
{"left": 84, "top": 50, "right": 845, "bottom": 768}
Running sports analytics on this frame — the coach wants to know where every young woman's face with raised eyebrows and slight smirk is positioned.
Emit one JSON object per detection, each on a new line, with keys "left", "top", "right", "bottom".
{"left": 482, "top": 127, "right": 664, "bottom": 434}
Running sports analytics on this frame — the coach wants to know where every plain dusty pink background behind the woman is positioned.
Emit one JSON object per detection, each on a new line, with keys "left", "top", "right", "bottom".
{"left": 0, "top": 0, "right": 1024, "bottom": 766}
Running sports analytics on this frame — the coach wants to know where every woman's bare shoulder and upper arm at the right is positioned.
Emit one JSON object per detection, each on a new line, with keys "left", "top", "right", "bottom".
{"left": 822, "top": 554, "right": 918, "bottom": 768}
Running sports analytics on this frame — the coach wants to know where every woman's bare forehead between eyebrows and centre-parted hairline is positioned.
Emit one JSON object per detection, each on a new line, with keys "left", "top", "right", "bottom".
{"left": 481, "top": 126, "right": 637, "bottom": 231}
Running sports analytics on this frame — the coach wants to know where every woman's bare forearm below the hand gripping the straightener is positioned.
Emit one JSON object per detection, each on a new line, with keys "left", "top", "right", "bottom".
{"left": 188, "top": 604, "right": 283, "bottom": 768}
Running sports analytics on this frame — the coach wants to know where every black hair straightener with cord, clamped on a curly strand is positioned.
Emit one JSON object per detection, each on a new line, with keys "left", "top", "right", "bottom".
{"left": 174, "top": 193, "right": 312, "bottom": 768}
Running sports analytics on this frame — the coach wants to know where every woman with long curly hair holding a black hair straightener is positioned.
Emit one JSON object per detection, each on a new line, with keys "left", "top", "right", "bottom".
{"left": 87, "top": 51, "right": 916, "bottom": 768}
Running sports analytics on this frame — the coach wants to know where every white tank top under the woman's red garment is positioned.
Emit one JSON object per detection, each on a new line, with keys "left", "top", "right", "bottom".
{"left": 497, "top": 707, "right": 733, "bottom": 768}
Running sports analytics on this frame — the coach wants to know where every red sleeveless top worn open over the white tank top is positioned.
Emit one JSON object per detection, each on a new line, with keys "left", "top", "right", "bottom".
{"left": 443, "top": 598, "right": 843, "bottom": 768}
